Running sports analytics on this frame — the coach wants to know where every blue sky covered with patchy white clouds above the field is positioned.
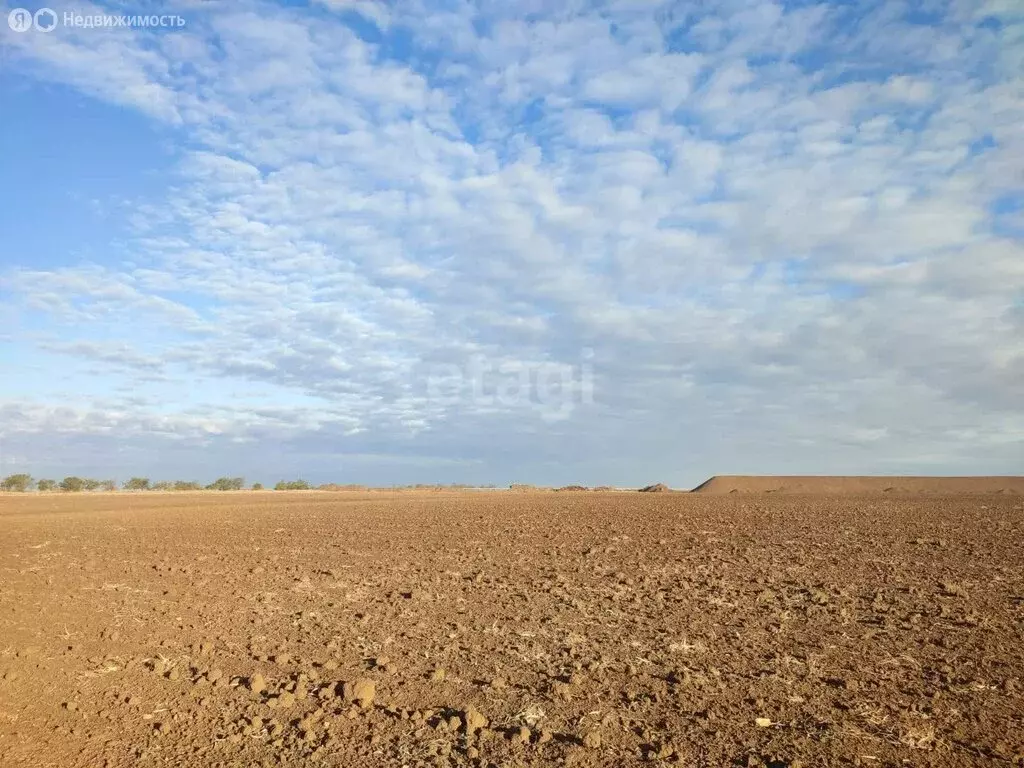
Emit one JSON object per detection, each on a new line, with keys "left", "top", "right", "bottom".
{"left": 0, "top": 0, "right": 1024, "bottom": 486}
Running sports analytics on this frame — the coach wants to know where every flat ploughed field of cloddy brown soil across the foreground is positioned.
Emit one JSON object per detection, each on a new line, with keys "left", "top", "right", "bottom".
{"left": 0, "top": 492, "right": 1024, "bottom": 768}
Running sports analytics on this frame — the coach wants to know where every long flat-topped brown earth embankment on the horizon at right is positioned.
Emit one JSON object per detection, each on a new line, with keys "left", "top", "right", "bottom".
{"left": 692, "top": 475, "right": 1024, "bottom": 495}
